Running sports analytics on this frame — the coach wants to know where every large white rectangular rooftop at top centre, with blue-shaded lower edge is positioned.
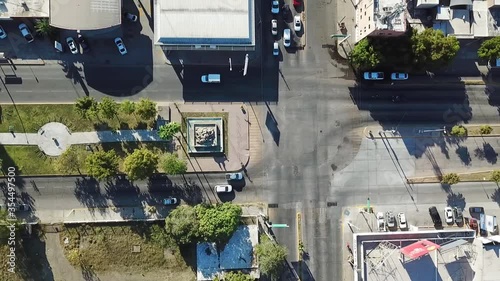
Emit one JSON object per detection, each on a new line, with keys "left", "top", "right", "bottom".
{"left": 154, "top": 0, "right": 255, "bottom": 45}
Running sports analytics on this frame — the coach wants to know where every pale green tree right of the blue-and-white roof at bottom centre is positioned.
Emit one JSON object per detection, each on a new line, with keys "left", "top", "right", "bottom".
{"left": 255, "top": 234, "right": 287, "bottom": 279}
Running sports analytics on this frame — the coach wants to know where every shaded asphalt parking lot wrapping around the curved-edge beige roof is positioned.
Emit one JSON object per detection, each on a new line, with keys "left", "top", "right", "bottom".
{"left": 0, "top": 1, "right": 165, "bottom": 65}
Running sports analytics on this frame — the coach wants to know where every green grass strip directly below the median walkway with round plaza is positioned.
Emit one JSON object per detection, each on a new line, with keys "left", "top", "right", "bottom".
{"left": 0, "top": 142, "right": 171, "bottom": 175}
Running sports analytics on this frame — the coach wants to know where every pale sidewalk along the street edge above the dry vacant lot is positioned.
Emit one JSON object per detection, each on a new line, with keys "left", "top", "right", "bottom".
{"left": 17, "top": 203, "right": 267, "bottom": 224}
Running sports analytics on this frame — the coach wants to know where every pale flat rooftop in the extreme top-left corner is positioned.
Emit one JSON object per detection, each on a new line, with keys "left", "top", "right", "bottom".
{"left": 0, "top": 0, "right": 49, "bottom": 18}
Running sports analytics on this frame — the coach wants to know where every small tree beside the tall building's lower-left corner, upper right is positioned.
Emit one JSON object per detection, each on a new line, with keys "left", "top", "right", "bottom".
{"left": 349, "top": 38, "right": 383, "bottom": 70}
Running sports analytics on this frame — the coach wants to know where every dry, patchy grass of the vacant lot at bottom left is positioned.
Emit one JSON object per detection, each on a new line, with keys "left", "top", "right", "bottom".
{"left": 60, "top": 224, "right": 196, "bottom": 279}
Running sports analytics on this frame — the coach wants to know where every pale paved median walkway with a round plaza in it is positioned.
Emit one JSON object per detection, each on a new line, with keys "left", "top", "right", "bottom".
{"left": 0, "top": 122, "right": 163, "bottom": 156}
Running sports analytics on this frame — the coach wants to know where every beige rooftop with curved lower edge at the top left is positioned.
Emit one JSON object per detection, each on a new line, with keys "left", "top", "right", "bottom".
{"left": 50, "top": 0, "right": 121, "bottom": 30}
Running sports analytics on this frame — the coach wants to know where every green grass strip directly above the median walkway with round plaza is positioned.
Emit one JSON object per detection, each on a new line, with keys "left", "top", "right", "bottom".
{"left": 0, "top": 104, "right": 153, "bottom": 133}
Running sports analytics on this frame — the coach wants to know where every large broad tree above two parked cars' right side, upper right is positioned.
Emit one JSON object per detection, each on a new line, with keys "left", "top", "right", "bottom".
{"left": 411, "top": 28, "right": 460, "bottom": 67}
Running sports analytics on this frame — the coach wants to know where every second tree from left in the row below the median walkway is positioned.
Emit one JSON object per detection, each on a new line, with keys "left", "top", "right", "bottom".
{"left": 85, "top": 150, "right": 118, "bottom": 180}
